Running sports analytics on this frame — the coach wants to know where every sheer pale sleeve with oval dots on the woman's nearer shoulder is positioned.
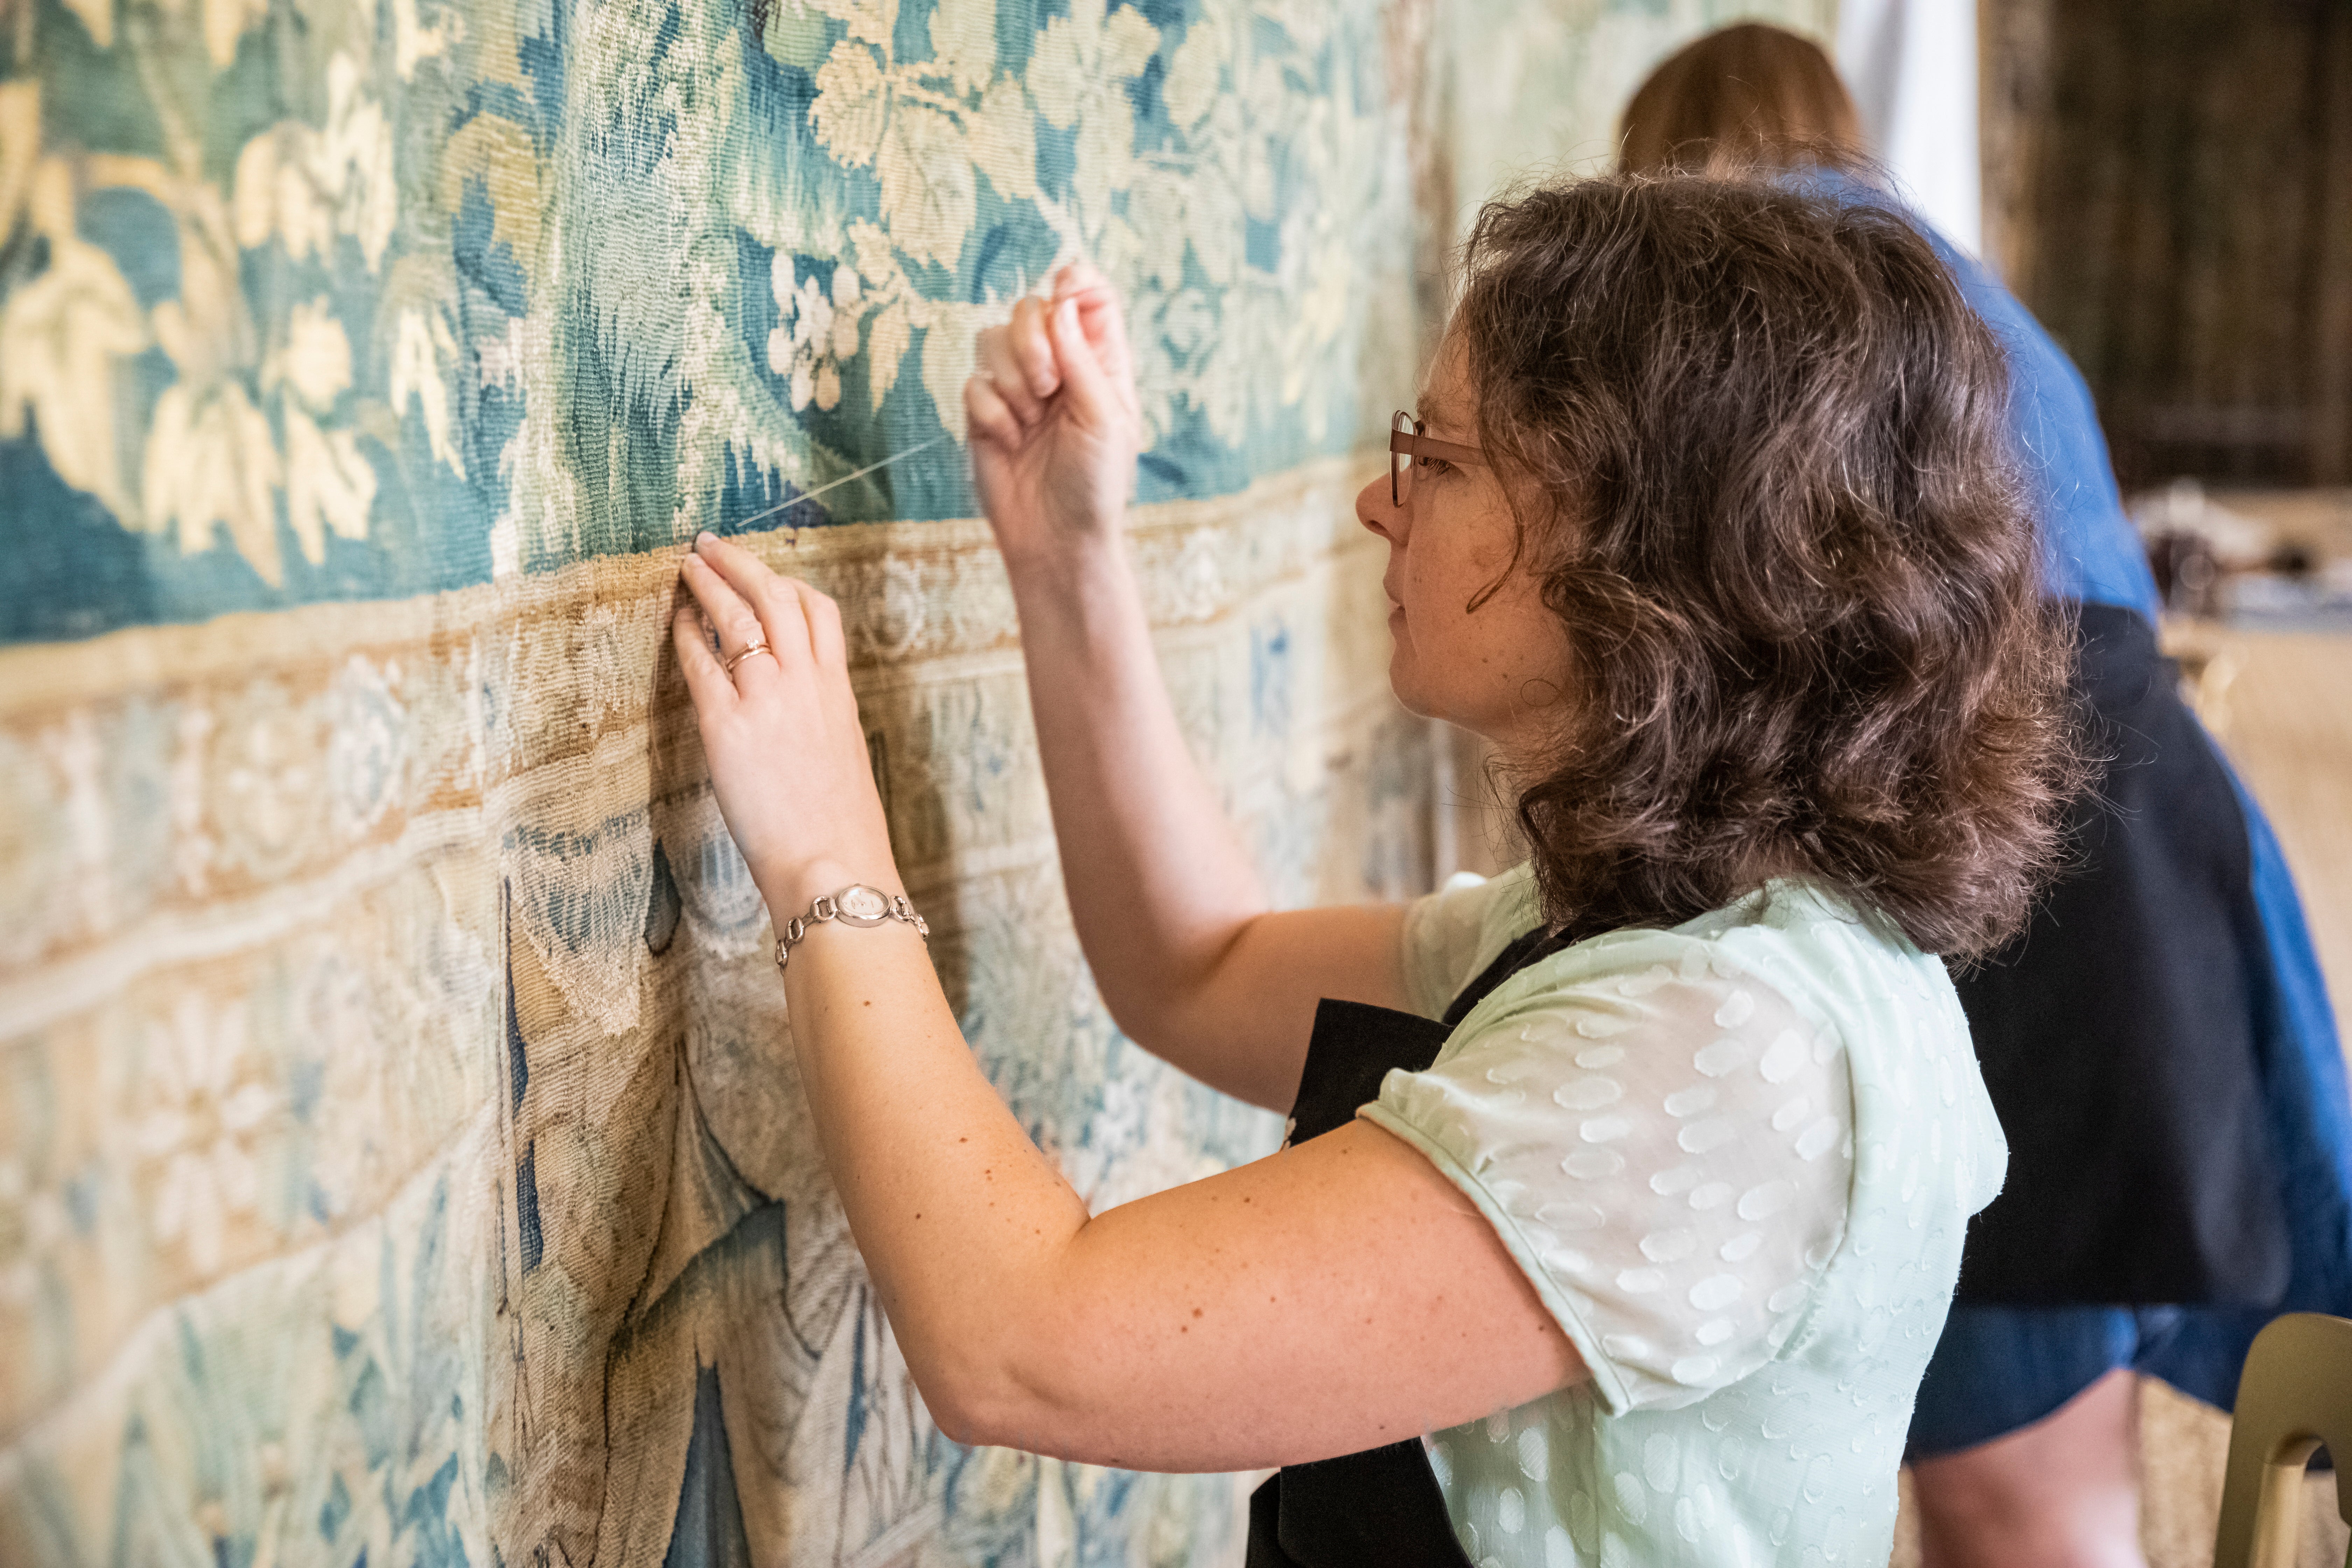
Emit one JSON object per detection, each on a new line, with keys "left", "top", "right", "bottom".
{"left": 1359, "top": 933, "right": 1853, "bottom": 1410}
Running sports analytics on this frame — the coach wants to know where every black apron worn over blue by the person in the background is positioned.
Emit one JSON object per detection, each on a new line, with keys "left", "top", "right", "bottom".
{"left": 1952, "top": 604, "right": 2291, "bottom": 1307}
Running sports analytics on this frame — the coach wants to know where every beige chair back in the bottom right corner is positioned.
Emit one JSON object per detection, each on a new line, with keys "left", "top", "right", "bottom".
{"left": 2213, "top": 1312, "right": 2352, "bottom": 1568}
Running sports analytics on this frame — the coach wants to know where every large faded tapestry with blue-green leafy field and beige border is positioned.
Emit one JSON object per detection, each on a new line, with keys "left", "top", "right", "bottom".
{"left": 0, "top": 0, "right": 1834, "bottom": 1568}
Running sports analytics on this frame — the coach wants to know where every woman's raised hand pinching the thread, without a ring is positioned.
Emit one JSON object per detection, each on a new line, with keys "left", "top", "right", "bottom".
{"left": 964, "top": 263, "right": 1143, "bottom": 569}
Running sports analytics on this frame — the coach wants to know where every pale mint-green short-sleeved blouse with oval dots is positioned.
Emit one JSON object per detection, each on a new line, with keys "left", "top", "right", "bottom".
{"left": 1359, "top": 867, "right": 2009, "bottom": 1568}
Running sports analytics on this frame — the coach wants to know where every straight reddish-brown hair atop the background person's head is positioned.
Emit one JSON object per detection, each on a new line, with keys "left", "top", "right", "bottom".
{"left": 1618, "top": 21, "right": 1865, "bottom": 174}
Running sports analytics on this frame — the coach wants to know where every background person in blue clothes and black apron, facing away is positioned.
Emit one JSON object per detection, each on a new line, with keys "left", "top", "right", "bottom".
{"left": 1620, "top": 23, "right": 2352, "bottom": 1568}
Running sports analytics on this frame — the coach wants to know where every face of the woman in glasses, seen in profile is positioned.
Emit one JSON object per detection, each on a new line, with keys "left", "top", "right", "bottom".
{"left": 1355, "top": 338, "right": 1569, "bottom": 757}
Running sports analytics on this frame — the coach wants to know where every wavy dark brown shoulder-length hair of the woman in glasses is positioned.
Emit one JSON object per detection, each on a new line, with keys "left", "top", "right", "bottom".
{"left": 1449, "top": 174, "right": 2084, "bottom": 959}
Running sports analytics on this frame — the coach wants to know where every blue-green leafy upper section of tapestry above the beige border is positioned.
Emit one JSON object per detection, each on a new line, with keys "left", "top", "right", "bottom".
{"left": 0, "top": 0, "right": 1411, "bottom": 642}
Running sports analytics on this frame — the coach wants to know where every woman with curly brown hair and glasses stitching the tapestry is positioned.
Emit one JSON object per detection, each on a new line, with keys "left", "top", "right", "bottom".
{"left": 677, "top": 178, "right": 2072, "bottom": 1568}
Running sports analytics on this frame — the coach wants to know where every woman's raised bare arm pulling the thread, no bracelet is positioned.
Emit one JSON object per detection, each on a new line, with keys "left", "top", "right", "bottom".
{"left": 964, "top": 268, "right": 1407, "bottom": 1110}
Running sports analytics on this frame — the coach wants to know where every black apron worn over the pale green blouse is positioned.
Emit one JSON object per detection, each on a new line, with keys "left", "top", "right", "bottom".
{"left": 1247, "top": 929, "right": 1571, "bottom": 1568}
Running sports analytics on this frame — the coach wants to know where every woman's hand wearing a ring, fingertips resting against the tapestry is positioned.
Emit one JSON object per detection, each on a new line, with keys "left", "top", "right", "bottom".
{"left": 670, "top": 534, "right": 903, "bottom": 924}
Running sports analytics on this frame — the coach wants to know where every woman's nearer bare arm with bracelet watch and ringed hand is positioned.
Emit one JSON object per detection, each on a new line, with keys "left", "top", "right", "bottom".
{"left": 675, "top": 536, "right": 1583, "bottom": 1469}
